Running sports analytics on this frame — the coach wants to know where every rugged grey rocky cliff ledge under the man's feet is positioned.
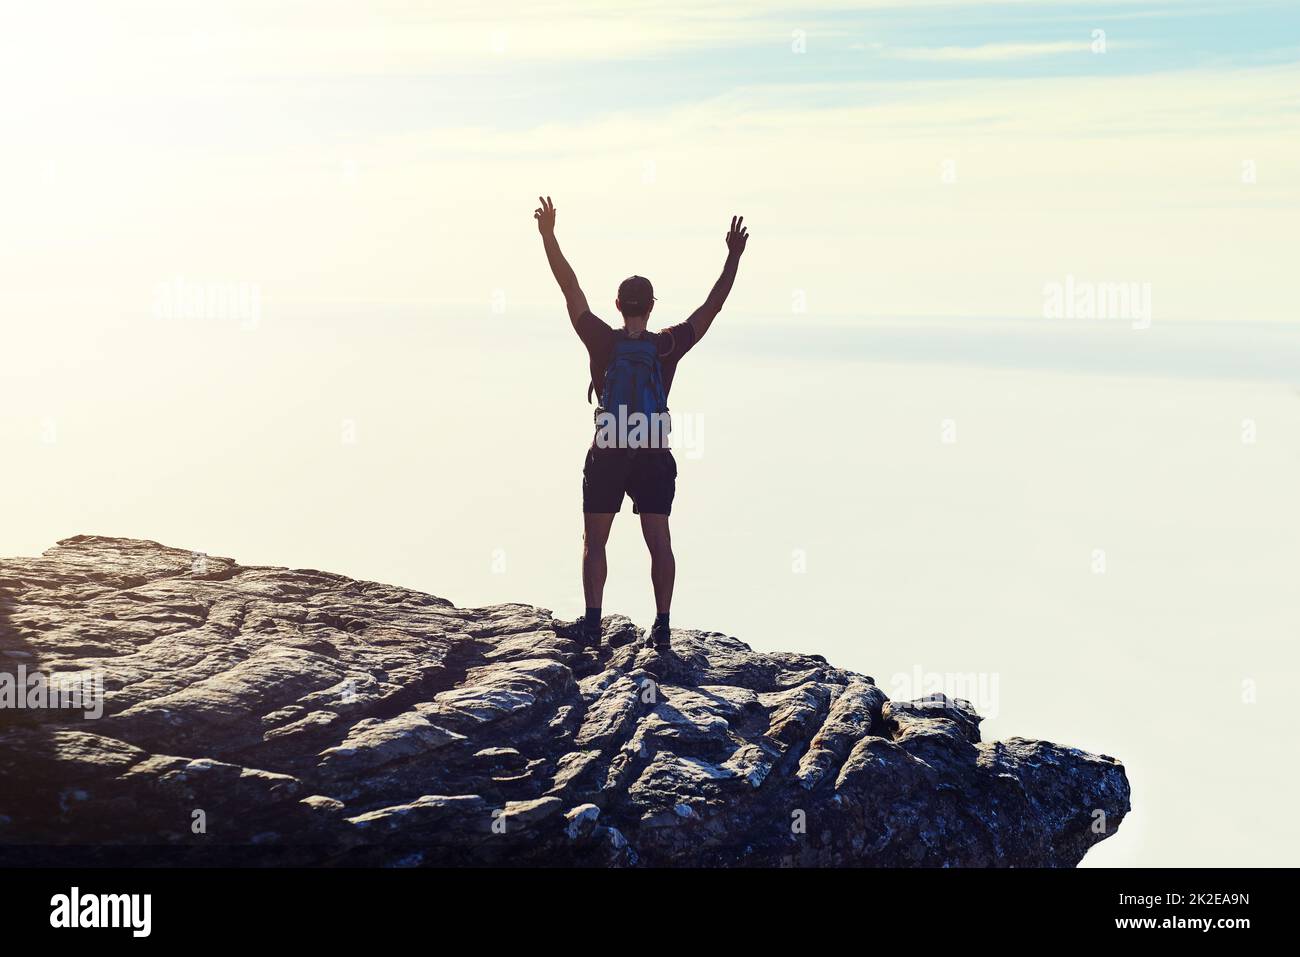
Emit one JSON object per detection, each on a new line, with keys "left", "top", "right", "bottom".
{"left": 0, "top": 536, "right": 1128, "bottom": 866}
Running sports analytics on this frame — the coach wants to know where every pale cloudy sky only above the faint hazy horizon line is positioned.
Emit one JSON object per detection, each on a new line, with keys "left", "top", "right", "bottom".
{"left": 0, "top": 1, "right": 1300, "bottom": 320}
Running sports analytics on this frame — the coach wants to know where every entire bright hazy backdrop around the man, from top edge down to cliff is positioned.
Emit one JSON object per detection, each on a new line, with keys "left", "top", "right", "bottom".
{"left": 0, "top": 0, "right": 1300, "bottom": 866}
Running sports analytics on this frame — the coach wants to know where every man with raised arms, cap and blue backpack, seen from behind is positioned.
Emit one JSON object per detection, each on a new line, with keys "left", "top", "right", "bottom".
{"left": 533, "top": 196, "right": 749, "bottom": 649}
